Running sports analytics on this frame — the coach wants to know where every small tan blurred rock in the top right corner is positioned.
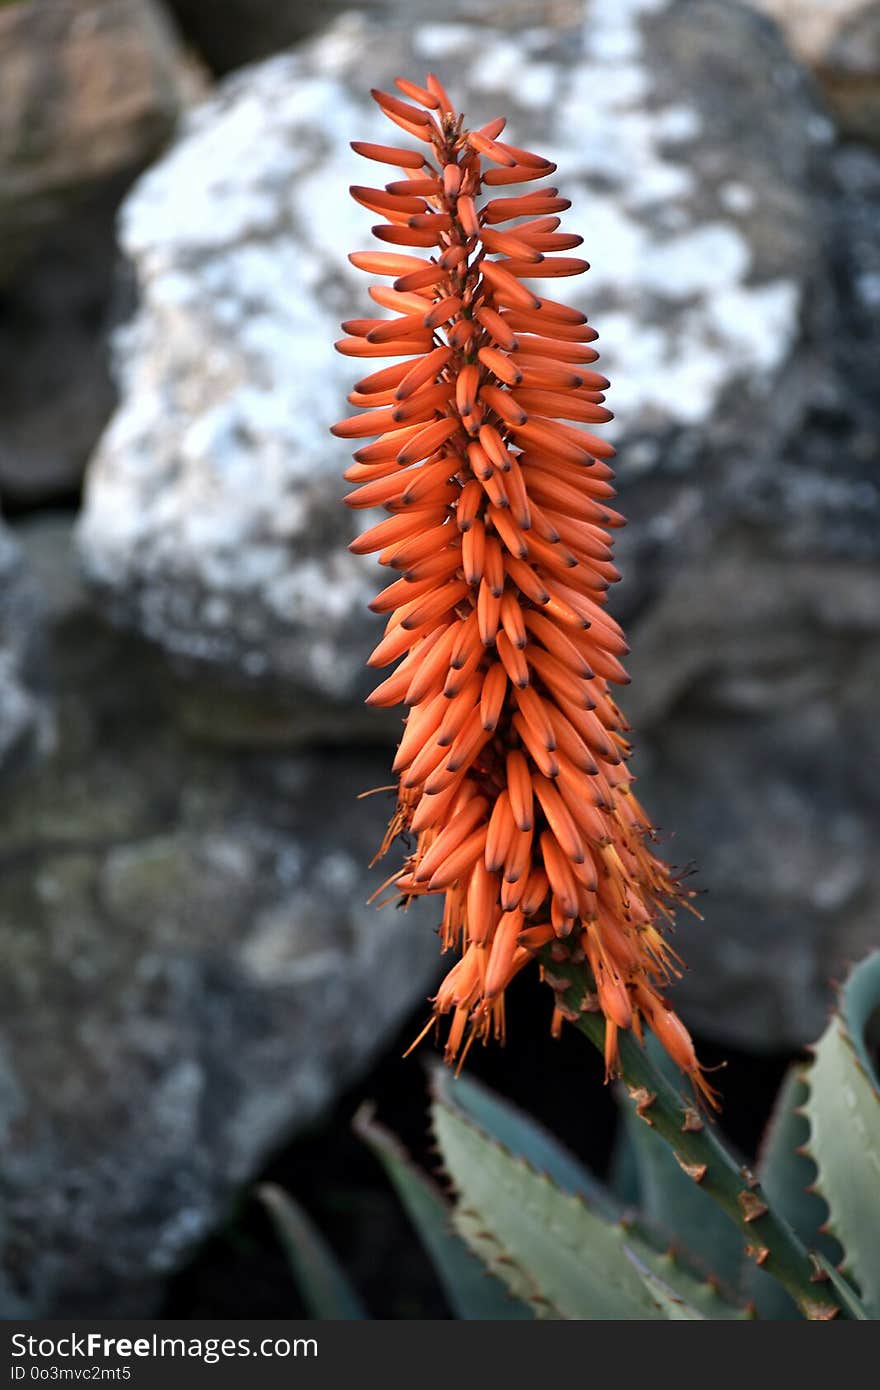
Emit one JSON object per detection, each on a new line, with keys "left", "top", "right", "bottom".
{"left": 748, "top": 0, "right": 880, "bottom": 143}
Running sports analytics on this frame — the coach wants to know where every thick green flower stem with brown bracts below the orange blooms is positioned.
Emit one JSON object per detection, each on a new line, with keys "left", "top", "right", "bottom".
{"left": 544, "top": 951, "right": 848, "bottom": 1321}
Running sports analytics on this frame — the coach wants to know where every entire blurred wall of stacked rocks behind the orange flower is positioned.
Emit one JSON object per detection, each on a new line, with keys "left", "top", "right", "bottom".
{"left": 0, "top": 0, "right": 880, "bottom": 1318}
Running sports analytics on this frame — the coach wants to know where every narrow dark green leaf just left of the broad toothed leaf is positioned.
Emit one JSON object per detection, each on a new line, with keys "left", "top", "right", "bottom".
{"left": 353, "top": 1106, "right": 534, "bottom": 1322}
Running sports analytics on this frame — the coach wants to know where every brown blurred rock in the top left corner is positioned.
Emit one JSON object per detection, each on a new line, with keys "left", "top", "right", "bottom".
{"left": 0, "top": 0, "right": 186, "bottom": 282}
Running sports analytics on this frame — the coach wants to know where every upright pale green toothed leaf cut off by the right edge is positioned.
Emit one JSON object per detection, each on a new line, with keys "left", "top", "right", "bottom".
{"left": 805, "top": 952, "right": 880, "bottom": 1318}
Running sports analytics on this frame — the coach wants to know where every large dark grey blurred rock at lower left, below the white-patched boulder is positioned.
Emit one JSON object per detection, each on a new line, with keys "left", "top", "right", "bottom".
{"left": 0, "top": 521, "right": 438, "bottom": 1318}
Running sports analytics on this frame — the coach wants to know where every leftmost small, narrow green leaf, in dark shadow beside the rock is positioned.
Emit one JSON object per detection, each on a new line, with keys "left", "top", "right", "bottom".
{"left": 257, "top": 1183, "right": 368, "bottom": 1322}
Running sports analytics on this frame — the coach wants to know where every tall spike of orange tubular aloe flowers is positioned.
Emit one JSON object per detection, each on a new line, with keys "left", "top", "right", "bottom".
{"left": 334, "top": 75, "right": 709, "bottom": 1094}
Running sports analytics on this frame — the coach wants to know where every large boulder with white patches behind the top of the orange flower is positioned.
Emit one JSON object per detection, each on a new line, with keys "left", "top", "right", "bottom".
{"left": 79, "top": 0, "right": 829, "bottom": 706}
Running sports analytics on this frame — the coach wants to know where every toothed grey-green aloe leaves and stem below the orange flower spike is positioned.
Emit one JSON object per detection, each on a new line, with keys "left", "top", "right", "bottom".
{"left": 262, "top": 952, "right": 880, "bottom": 1321}
